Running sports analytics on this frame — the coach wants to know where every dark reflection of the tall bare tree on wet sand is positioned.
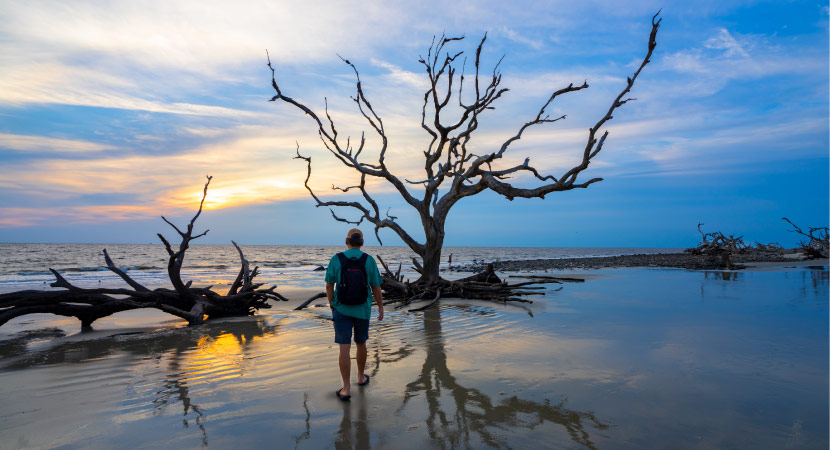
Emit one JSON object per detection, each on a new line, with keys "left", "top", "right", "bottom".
{"left": 401, "top": 308, "right": 608, "bottom": 448}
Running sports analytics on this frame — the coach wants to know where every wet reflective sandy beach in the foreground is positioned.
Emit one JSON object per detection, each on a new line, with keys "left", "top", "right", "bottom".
{"left": 0, "top": 250, "right": 828, "bottom": 449}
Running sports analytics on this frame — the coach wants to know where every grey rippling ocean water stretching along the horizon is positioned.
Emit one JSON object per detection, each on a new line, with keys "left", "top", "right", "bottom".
{"left": 0, "top": 244, "right": 680, "bottom": 292}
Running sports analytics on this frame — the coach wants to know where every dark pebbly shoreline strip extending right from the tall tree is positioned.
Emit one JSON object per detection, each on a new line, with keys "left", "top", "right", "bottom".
{"left": 451, "top": 251, "right": 828, "bottom": 273}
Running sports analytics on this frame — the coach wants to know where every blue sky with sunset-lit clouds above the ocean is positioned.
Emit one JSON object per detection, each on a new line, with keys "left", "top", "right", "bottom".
{"left": 0, "top": 0, "right": 830, "bottom": 247}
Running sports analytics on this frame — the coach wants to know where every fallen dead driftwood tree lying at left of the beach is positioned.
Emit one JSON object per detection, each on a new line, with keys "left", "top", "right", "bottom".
{"left": 0, "top": 176, "right": 300, "bottom": 329}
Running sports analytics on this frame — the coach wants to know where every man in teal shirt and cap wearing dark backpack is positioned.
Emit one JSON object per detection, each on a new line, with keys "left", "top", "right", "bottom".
{"left": 326, "top": 228, "right": 383, "bottom": 400}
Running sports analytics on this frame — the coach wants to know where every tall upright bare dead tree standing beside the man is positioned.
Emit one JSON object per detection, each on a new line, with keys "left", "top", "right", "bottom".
{"left": 268, "top": 12, "right": 661, "bottom": 300}
